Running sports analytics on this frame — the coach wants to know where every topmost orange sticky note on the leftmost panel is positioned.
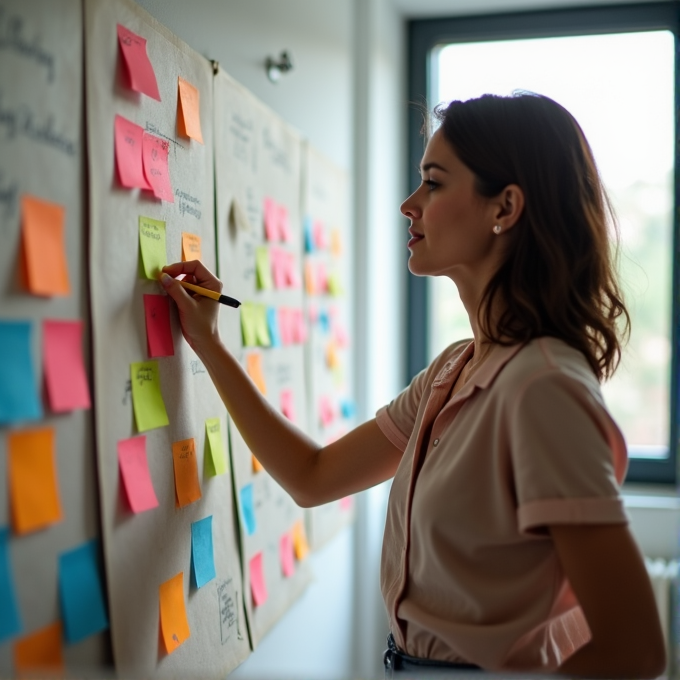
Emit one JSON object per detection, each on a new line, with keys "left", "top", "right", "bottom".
{"left": 21, "top": 195, "right": 71, "bottom": 295}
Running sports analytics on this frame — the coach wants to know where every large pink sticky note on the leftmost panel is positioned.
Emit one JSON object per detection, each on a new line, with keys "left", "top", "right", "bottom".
{"left": 43, "top": 319, "right": 90, "bottom": 413}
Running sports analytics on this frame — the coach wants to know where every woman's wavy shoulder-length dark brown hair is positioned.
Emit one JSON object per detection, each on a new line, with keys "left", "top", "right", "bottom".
{"left": 435, "top": 93, "right": 630, "bottom": 380}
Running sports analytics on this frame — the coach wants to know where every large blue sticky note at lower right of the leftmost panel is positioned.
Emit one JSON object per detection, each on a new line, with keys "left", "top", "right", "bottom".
{"left": 59, "top": 540, "right": 109, "bottom": 643}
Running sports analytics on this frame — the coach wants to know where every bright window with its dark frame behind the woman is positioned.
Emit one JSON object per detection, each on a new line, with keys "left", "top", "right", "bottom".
{"left": 409, "top": 5, "right": 676, "bottom": 482}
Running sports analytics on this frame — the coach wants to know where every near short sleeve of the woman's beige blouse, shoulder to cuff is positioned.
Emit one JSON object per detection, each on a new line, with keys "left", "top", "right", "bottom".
{"left": 509, "top": 370, "right": 628, "bottom": 532}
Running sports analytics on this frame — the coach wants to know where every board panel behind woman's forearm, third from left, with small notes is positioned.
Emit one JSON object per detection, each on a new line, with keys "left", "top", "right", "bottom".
{"left": 215, "top": 72, "right": 310, "bottom": 648}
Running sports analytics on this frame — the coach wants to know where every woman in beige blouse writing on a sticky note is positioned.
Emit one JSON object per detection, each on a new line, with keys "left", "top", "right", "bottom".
{"left": 162, "top": 94, "right": 665, "bottom": 678}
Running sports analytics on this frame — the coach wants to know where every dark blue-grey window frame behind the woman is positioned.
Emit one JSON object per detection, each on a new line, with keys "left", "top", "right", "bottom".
{"left": 405, "top": 0, "right": 680, "bottom": 484}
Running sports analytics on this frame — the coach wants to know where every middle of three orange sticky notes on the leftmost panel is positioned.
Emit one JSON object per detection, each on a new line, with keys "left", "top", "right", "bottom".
{"left": 7, "top": 427, "right": 62, "bottom": 534}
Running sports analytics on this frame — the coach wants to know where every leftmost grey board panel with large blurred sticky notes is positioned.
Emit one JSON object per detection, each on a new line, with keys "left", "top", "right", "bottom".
{"left": 0, "top": 0, "right": 110, "bottom": 677}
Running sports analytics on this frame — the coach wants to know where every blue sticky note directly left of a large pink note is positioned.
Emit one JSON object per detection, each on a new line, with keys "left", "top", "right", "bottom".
{"left": 0, "top": 321, "right": 42, "bottom": 425}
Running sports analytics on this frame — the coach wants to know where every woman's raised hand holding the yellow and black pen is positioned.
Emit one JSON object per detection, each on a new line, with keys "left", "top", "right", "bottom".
{"left": 161, "top": 260, "right": 222, "bottom": 355}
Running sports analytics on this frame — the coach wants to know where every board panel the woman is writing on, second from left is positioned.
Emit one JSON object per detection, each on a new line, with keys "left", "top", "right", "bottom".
{"left": 85, "top": 0, "right": 249, "bottom": 678}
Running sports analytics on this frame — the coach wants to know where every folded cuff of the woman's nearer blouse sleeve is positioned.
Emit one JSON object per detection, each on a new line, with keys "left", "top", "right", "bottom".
{"left": 517, "top": 498, "right": 628, "bottom": 533}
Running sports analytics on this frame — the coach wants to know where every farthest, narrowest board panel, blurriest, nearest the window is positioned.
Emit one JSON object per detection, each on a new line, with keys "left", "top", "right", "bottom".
{"left": 302, "top": 143, "right": 355, "bottom": 549}
